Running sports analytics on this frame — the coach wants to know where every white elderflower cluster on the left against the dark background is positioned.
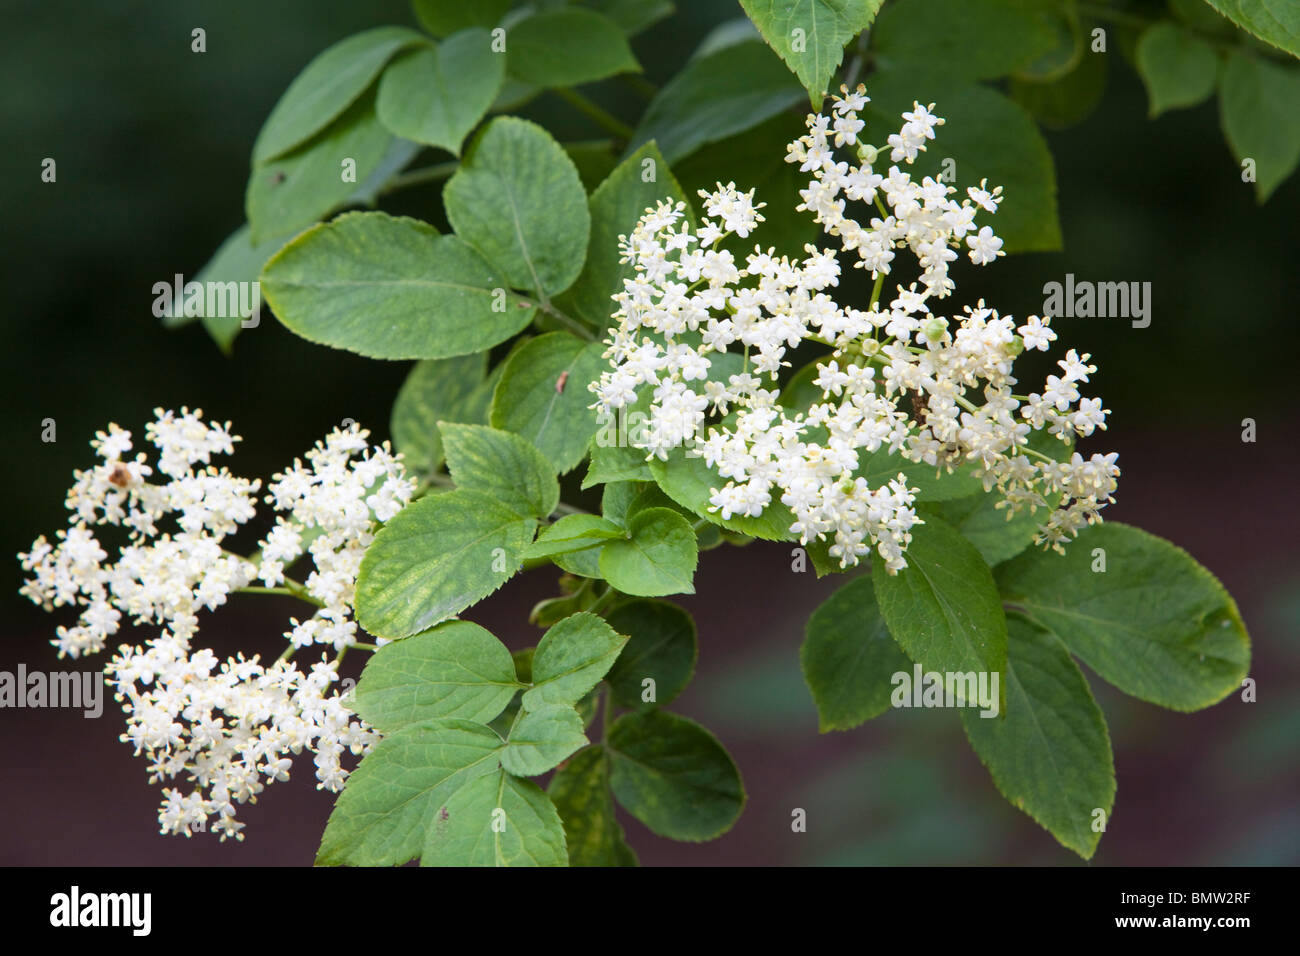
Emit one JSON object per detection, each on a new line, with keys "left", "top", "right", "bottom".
{"left": 18, "top": 408, "right": 415, "bottom": 839}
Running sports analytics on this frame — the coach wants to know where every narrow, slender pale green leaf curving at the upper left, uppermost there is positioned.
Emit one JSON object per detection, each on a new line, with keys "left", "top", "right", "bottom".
{"left": 252, "top": 26, "right": 426, "bottom": 166}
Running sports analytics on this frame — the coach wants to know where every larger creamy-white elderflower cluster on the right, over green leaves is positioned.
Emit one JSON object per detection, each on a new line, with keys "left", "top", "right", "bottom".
{"left": 592, "top": 86, "right": 1119, "bottom": 574}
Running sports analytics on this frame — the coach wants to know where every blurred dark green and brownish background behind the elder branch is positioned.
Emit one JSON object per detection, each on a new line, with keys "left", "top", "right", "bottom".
{"left": 0, "top": 0, "right": 1300, "bottom": 865}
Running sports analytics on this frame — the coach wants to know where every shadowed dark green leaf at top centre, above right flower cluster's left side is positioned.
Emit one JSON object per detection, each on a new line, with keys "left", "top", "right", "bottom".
{"left": 628, "top": 40, "right": 803, "bottom": 164}
